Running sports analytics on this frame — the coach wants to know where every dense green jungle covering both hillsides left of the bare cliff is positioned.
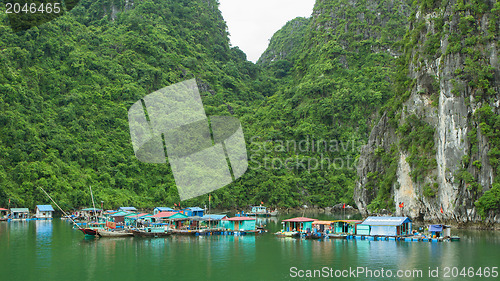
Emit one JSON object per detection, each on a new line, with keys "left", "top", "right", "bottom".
{"left": 0, "top": 0, "right": 500, "bottom": 214}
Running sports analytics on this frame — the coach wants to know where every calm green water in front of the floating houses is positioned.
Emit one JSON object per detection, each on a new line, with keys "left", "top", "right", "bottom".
{"left": 0, "top": 218, "right": 500, "bottom": 280}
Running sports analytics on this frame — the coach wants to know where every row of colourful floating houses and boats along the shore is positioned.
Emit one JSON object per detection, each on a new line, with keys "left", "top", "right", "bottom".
{"left": 0, "top": 202, "right": 459, "bottom": 242}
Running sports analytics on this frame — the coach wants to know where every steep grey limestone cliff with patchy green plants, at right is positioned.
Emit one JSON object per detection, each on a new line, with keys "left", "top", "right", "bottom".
{"left": 354, "top": 0, "right": 500, "bottom": 224}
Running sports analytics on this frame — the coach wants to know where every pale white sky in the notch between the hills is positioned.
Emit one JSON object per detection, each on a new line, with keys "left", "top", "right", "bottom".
{"left": 219, "top": 0, "right": 315, "bottom": 62}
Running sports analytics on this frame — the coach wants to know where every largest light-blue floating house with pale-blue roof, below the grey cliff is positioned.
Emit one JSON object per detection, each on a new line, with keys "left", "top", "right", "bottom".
{"left": 357, "top": 217, "right": 411, "bottom": 236}
